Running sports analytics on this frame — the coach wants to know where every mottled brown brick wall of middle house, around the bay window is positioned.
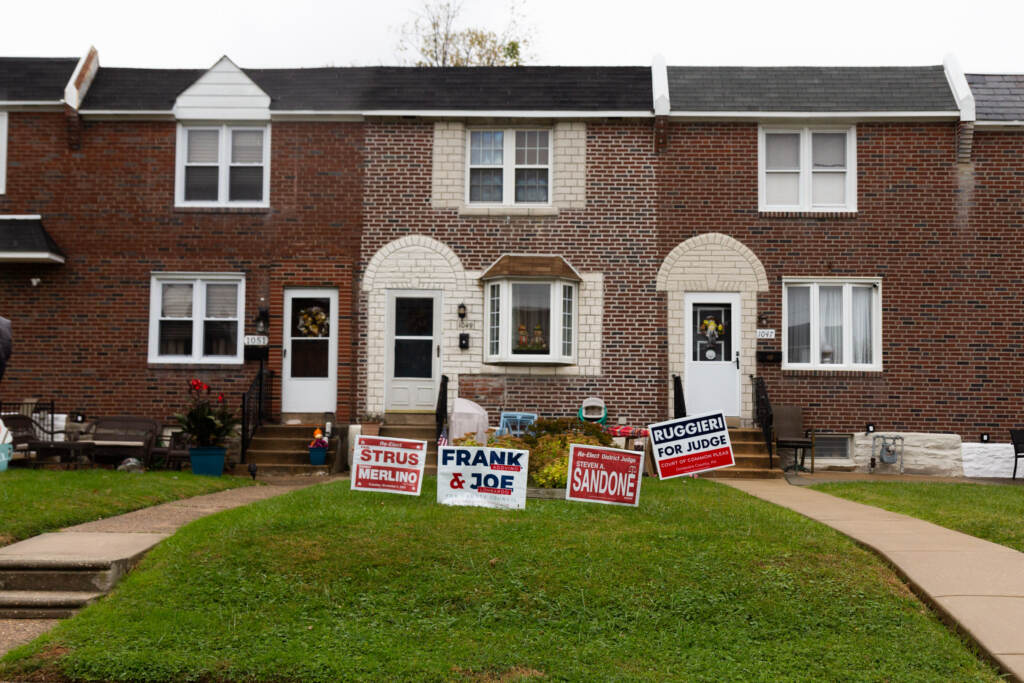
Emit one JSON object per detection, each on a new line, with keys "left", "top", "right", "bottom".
{"left": 358, "top": 121, "right": 668, "bottom": 424}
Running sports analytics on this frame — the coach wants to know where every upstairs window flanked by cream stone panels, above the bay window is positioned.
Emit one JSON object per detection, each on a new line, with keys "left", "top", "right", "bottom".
{"left": 466, "top": 129, "right": 551, "bottom": 205}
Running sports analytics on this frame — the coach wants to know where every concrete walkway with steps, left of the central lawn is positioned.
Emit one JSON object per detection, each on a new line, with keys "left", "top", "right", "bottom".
{"left": 0, "top": 477, "right": 339, "bottom": 655}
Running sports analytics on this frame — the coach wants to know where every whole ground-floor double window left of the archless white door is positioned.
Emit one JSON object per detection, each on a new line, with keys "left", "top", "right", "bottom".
{"left": 150, "top": 273, "right": 245, "bottom": 364}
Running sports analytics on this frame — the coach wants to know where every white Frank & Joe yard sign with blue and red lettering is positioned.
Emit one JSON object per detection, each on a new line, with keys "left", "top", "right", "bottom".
{"left": 437, "top": 445, "right": 529, "bottom": 510}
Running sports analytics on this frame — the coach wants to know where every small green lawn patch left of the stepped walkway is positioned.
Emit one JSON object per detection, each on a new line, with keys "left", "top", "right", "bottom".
{"left": 0, "top": 469, "right": 251, "bottom": 546}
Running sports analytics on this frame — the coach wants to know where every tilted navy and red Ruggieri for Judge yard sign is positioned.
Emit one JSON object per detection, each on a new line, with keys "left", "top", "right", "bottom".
{"left": 648, "top": 412, "right": 736, "bottom": 479}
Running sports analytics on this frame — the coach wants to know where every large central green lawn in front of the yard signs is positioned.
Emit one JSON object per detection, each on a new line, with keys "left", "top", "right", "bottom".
{"left": 0, "top": 477, "right": 997, "bottom": 681}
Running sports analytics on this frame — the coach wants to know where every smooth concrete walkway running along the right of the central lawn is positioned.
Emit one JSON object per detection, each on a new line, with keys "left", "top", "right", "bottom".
{"left": 720, "top": 479, "right": 1024, "bottom": 680}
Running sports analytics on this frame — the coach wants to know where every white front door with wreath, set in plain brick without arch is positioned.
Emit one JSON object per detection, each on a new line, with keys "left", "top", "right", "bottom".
{"left": 281, "top": 288, "right": 338, "bottom": 413}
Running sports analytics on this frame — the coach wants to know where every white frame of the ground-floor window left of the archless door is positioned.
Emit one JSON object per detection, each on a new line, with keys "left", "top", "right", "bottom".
{"left": 148, "top": 272, "right": 246, "bottom": 366}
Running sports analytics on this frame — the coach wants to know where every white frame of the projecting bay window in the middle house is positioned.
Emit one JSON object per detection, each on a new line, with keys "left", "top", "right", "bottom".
{"left": 483, "top": 276, "right": 580, "bottom": 366}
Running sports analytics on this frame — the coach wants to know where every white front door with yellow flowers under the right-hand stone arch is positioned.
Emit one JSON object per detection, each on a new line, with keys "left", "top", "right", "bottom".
{"left": 683, "top": 293, "right": 740, "bottom": 416}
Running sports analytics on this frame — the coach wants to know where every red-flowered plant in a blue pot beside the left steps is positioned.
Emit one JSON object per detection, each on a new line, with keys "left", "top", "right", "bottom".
{"left": 174, "top": 380, "right": 239, "bottom": 476}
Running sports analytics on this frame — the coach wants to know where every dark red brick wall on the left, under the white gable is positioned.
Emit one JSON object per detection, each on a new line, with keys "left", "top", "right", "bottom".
{"left": 0, "top": 113, "right": 364, "bottom": 419}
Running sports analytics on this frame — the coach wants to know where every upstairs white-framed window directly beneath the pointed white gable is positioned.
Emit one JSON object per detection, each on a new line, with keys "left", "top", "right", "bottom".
{"left": 175, "top": 125, "right": 270, "bottom": 207}
